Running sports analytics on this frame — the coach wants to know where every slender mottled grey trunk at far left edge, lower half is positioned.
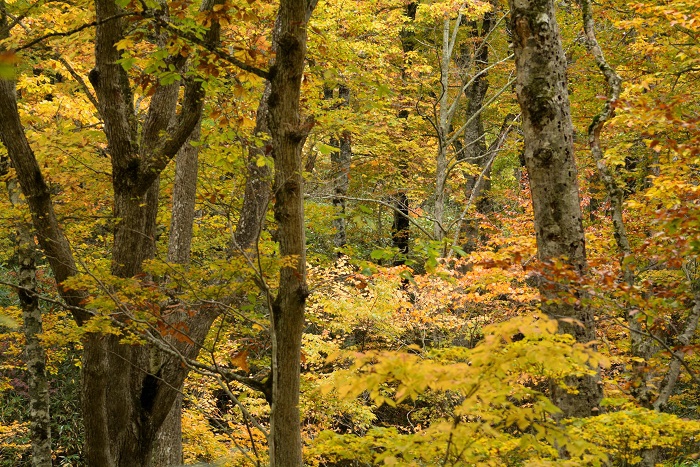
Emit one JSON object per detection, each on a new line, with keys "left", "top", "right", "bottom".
{"left": 0, "top": 156, "right": 51, "bottom": 467}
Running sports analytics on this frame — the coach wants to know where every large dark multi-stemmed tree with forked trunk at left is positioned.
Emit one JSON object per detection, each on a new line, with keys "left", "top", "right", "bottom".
{"left": 0, "top": 0, "right": 224, "bottom": 466}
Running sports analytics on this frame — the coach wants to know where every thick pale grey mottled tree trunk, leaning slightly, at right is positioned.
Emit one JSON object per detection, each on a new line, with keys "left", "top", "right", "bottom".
{"left": 510, "top": 0, "right": 602, "bottom": 417}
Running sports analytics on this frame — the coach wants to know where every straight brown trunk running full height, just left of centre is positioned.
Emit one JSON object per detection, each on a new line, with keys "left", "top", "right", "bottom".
{"left": 268, "top": 0, "right": 316, "bottom": 467}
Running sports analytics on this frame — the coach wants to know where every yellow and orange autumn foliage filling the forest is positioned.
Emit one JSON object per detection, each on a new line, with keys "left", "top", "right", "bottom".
{"left": 0, "top": 0, "right": 700, "bottom": 466}
